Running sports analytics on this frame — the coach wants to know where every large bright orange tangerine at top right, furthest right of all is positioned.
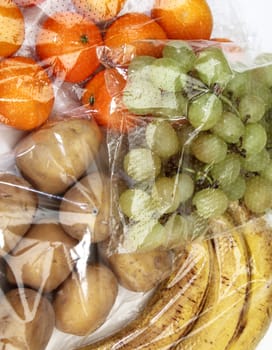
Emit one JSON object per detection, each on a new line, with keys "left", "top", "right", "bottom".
{"left": 151, "top": 0, "right": 213, "bottom": 40}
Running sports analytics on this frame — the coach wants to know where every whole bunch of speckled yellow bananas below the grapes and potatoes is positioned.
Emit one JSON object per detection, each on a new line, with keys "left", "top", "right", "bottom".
{"left": 76, "top": 203, "right": 272, "bottom": 350}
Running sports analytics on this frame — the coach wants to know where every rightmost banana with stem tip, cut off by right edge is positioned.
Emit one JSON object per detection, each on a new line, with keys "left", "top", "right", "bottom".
{"left": 228, "top": 203, "right": 272, "bottom": 350}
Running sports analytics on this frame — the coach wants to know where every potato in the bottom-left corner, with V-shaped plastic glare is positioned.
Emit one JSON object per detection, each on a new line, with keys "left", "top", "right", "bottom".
{"left": 0, "top": 288, "right": 55, "bottom": 350}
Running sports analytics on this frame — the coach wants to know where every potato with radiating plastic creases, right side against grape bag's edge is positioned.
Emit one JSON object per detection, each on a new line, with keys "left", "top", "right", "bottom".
{"left": 59, "top": 172, "right": 110, "bottom": 242}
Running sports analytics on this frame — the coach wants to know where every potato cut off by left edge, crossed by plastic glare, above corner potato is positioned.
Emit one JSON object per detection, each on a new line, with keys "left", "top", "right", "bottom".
{"left": 0, "top": 173, "right": 38, "bottom": 256}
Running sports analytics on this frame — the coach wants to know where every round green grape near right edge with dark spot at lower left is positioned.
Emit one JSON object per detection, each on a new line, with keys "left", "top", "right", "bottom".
{"left": 238, "top": 94, "right": 265, "bottom": 123}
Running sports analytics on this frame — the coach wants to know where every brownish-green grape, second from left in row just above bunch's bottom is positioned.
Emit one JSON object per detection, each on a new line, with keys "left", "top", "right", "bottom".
{"left": 151, "top": 176, "right": 180, "bottom": 214}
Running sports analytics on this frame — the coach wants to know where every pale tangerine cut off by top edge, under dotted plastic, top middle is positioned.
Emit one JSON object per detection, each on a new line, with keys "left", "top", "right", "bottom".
{"left": 72, "top": 0, "right": 126, "bottom": 22}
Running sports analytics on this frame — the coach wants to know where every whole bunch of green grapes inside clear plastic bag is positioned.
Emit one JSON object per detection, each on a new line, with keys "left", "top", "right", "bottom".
{"left": 116, "top": 41, "right": 272, "bottom": 248}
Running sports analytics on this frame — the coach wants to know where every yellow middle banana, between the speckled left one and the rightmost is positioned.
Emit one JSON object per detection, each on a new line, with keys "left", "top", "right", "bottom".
{"left": 176, "top": 215, "right": 249, "bottom": 350}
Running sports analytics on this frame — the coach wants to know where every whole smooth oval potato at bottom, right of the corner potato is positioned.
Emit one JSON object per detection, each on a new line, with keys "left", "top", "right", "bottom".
{"left": 53, "top": 264, "right": 118, "bottom": 336}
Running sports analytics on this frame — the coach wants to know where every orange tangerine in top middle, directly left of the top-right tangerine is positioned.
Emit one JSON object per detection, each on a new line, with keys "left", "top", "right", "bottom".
{"left": 105, "top": 12, "right": 167, "bottom": 57}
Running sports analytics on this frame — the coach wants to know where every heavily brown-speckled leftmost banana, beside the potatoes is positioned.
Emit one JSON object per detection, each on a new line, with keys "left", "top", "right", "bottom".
{"left": 77, "top": 240, "right": 212, "bottom": 350}
